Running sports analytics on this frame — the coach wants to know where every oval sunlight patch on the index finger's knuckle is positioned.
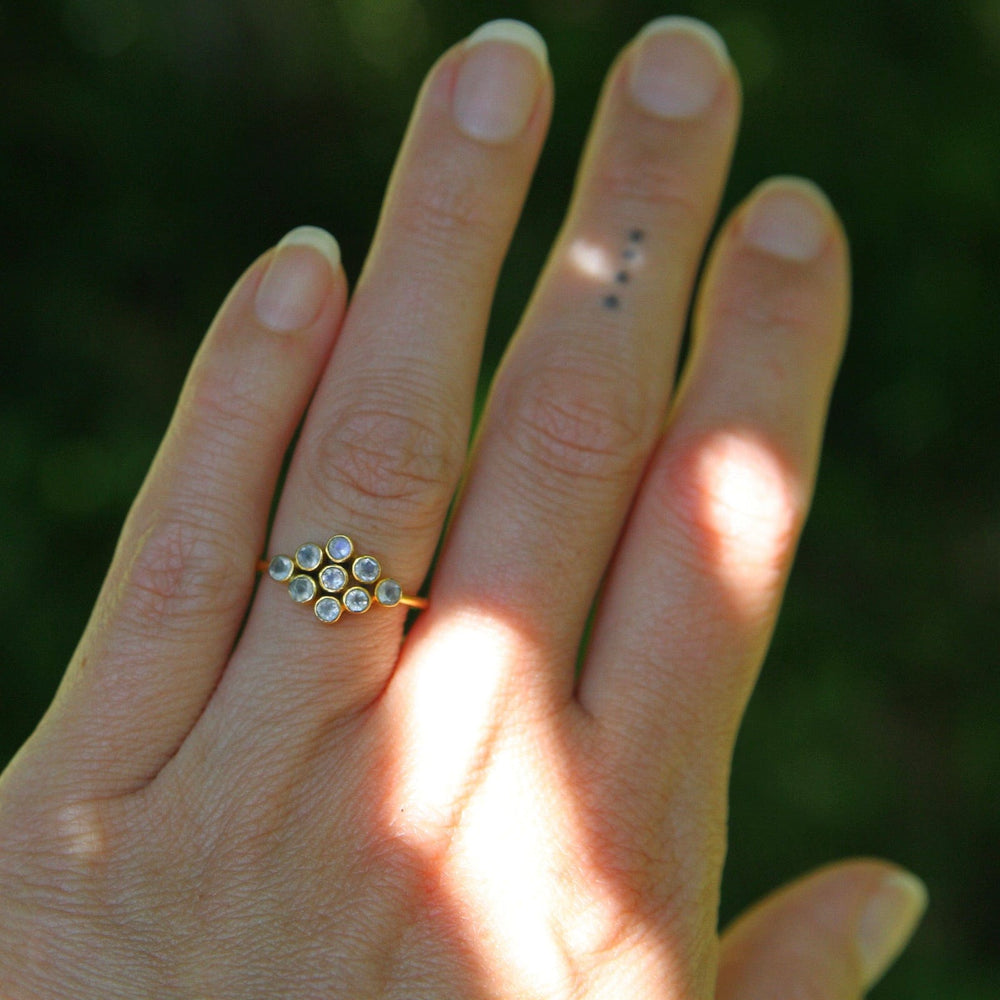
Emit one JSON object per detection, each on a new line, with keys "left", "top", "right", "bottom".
{"left": 693, "top": 430, "right": 799, "bottom": 614}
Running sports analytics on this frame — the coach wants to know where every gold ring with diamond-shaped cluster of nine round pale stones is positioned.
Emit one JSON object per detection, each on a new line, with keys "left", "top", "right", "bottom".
{"left": 257, "top": 535, "right": 427, "bottom": 625}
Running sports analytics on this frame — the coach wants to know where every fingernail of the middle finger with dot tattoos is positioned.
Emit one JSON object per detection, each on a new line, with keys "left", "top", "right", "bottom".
{"left": 630, "top": 17, "right": 729, "bottom": 118}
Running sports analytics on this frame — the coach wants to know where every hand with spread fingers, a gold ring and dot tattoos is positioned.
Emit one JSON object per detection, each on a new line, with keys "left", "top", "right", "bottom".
{"left": 0, "top": 19, "right": 923, "bottom": 1000}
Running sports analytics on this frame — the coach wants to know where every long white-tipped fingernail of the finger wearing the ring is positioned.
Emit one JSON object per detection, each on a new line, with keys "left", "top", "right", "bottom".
{"left": 452, "top": 19, "right": 548, "bottom": 143}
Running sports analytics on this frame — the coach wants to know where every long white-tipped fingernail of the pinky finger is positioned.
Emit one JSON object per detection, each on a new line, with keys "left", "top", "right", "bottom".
{"left": 254, "top": 226, "right": 340, "bottom": 332}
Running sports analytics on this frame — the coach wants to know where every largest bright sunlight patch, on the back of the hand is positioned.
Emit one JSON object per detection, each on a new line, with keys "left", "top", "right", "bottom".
{"left": 384, "top": 606, "right": 680, "bottom": 997}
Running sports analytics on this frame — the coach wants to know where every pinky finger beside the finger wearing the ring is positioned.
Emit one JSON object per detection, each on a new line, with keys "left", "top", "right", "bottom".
{"left": 26, "top": 227, "right": 347, "bottom": 796}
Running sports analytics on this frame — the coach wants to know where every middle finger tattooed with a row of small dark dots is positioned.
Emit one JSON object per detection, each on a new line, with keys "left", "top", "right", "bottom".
{"left": 434, "top": 17, "right": 739, "bottom": 698}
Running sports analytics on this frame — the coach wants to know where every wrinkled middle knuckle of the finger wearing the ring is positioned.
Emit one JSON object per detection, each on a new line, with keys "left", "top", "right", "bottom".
{"left": 311, "top": 391, "right": 465, "bottom": 527}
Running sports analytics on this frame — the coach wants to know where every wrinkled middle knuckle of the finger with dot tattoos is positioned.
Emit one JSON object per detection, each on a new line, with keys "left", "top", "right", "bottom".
{"left": 502, "top": 367, "right": 652, "bottom": 482}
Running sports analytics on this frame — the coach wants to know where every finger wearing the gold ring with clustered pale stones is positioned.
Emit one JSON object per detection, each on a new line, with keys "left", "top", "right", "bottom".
{"left": 224, "top": 21, "right": 551, "bottom": 718}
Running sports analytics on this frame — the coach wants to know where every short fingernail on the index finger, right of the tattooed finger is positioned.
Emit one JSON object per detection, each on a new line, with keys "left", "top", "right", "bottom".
{"left": 743, "top": 177, "right": 833, "bottom": 262}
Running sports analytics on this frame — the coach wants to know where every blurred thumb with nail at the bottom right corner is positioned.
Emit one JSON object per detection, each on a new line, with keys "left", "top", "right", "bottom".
{"left": 715, "top": 860, "right": 927, "bottom": 1000}
